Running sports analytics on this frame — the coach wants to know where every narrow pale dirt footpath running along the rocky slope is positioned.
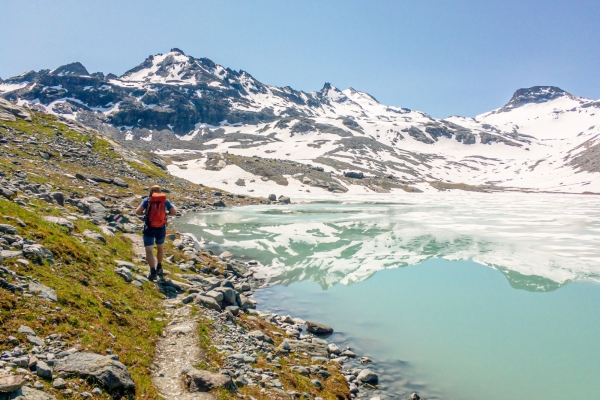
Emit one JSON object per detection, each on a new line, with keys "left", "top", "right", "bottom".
{"left": 126, "top": 234, "right": 216, "bottom": 400}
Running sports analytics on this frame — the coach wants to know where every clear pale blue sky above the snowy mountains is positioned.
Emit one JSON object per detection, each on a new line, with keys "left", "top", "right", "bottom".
{"left": 0, "top": 0, "right": 600, "bottom": 117}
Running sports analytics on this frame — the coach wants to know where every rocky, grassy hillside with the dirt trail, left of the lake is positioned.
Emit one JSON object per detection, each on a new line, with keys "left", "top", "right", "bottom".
{"left": 0, "top": 103, "right": 418, "bottom": 400}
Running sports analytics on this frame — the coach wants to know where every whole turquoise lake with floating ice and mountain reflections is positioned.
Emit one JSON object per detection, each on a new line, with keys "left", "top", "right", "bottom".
{"left": 176, "top": 193, "right": 600, "bottom": 400}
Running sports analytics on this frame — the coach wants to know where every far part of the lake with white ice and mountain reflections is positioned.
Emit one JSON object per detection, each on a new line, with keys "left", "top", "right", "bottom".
{"left": 176, "top": 192, "right": 600, "bottom": 291}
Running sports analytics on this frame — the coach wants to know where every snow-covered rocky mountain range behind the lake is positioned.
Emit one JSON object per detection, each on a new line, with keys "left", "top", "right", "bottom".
{"left": 0, "top": 49, "right": 600, "bottom": 197}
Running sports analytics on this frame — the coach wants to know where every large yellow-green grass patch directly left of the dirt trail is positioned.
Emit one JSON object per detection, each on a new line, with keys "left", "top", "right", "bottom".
{"left": 0, "top": 199, "right": 165, "bottom": 399}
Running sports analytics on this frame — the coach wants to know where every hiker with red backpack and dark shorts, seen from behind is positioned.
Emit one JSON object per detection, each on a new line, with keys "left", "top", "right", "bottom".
{"left": 135, "top": 185, "right": 177, "bottom": 281}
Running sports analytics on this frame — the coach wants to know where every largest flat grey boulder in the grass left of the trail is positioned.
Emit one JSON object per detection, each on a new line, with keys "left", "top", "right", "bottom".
{"left": 56, "top": 353, "right": 135, "bottom": 392}
